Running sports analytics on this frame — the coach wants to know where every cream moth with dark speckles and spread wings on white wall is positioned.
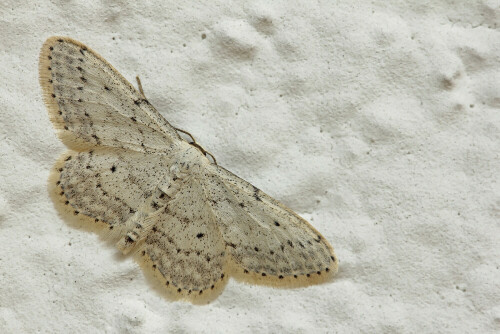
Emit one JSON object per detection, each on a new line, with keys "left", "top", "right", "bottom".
{"left": 39, "top": 37, "right": 338, "bottom": 303}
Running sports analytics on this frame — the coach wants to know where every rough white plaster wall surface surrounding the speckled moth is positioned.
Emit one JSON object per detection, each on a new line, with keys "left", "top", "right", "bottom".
{"left": 0, "top": 0, "right": 500, "bottom": 333}
